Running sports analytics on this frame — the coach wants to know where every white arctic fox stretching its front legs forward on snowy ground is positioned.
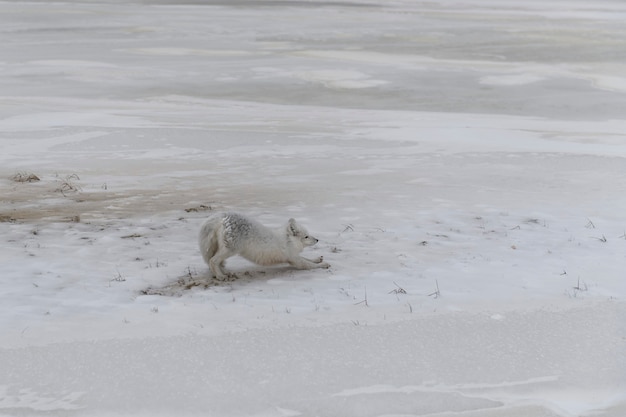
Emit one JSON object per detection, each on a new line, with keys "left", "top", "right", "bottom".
{"left": 199, "top": 213, "right": 330, "bottom": 280}
